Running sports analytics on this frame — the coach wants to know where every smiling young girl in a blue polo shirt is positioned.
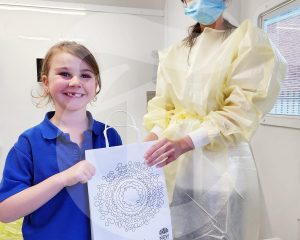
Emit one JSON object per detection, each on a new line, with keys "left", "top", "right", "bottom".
{"left": 0, "top": 42, "right": 121, "bottom": 240}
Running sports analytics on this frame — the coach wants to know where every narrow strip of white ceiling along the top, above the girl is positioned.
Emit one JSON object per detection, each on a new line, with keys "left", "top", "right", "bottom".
{"left": 41, "top": 0, "right": 165, "bottom": 10}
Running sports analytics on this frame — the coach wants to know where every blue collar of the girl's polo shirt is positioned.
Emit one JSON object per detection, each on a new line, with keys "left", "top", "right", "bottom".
{"left": 41, "top": 111, "right": 101, "bottom": 139}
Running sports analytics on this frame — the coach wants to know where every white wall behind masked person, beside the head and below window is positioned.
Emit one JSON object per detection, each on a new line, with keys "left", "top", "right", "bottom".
{"left": 165, "top": 0, "right": 300, "bottom": 240}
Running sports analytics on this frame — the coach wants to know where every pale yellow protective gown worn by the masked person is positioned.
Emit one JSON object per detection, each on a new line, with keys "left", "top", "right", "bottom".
{"left": 144, "top": 21, "right": 286, "bottom": 240}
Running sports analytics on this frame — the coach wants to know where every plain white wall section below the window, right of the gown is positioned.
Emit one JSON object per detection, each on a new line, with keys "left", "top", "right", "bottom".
{"left": 252, "top": 125, "right": 300, "bottom": 240}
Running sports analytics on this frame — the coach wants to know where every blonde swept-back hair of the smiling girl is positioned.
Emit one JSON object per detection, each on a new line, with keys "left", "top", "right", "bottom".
{"left": 31, "top": 41, "right": 101, "bottom": 107}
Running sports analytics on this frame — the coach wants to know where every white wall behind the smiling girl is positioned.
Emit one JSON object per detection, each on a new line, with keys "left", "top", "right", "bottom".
{"left": 0, "top": 1, "right": 164, "bottom": 171}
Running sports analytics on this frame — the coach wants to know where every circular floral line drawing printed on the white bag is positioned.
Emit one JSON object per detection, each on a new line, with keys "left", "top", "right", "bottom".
{"left": 94, "top": 162, "right": 164, "bottom": 232}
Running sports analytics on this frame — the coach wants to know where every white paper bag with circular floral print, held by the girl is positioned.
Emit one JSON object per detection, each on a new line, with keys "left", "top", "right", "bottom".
{"left": 86, "top": 142, "right": 173, "bottom": 240}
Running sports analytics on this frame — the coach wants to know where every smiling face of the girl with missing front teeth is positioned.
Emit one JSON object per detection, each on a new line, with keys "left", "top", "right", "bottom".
{"left": 42, "top": 52, "right": 98, "bottom": 111}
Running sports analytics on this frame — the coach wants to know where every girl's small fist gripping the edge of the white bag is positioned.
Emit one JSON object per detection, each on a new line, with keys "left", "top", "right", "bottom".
{"left": 59, "top": 160, "right": 96, "bottom": 187}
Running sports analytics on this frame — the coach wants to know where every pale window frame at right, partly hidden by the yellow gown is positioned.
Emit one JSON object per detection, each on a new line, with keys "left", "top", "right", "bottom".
{"left": 257, "top": 0, "right": 300, "bottom": 129}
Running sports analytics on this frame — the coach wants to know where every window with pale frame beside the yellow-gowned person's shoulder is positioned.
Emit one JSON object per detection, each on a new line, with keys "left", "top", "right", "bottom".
{"left": 259, "top": 0, "right": 300, "bottom": 128}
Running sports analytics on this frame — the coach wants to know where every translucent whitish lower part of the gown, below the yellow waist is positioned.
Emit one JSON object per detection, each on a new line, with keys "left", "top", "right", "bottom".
{"left": 171, "top": 143, "right": 260, "bottom": 240}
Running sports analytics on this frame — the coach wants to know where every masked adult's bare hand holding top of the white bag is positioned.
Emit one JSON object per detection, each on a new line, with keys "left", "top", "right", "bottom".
{"left": 145, "top": 136, "right": 194, "bottom": 167}
